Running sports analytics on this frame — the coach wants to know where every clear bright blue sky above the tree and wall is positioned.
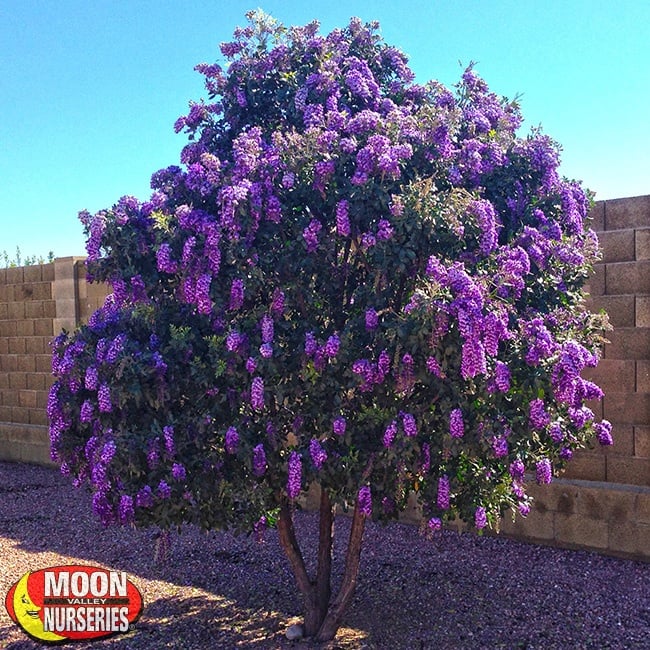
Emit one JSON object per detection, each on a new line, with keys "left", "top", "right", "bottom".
{"left": 0, "top": 0, "right": 650, "bottom": 257}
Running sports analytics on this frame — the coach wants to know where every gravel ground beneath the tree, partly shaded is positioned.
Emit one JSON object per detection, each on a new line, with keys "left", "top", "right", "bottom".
{"left": 0, "top": 463, "right": 650, "bottom": 650}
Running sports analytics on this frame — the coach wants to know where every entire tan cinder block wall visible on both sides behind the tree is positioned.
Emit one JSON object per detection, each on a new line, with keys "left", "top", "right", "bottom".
{"left": 0, "top": 195, "right": 650, "bottom": 561}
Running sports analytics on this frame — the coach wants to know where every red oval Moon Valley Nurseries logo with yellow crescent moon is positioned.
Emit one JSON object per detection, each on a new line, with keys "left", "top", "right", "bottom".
{"left": 5, "top": 565, "right": 143, "bottom": 643}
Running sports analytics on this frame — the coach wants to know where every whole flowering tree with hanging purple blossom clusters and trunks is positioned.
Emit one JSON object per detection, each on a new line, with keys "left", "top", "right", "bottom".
{"left": 49, "top": 13, "right": 611, "bottom": 640}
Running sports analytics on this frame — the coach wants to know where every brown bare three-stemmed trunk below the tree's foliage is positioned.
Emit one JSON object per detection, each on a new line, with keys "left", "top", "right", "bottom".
{"left": 278, "top": 490, "right": 365, "bottom": 642}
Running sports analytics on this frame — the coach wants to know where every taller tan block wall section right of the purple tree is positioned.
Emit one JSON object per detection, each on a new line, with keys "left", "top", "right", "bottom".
{"left": 504, "top": 196, "right": 650, "bottom": 561}
